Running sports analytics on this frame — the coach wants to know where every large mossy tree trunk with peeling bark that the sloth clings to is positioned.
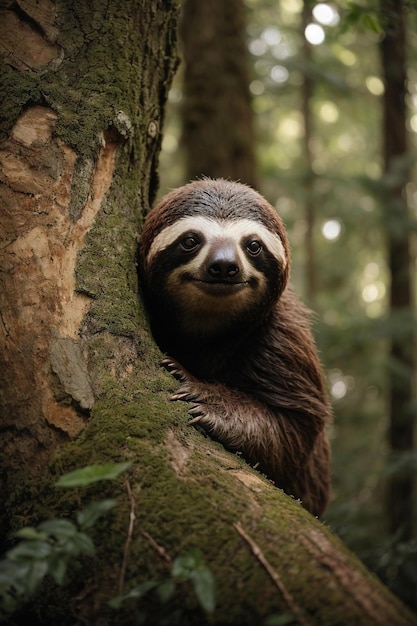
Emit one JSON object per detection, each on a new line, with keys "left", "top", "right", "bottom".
{"left": 0, "top": 0, "right": 417, "bottom": 626}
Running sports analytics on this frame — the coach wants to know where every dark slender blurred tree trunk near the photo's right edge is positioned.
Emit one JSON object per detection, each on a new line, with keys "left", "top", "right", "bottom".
{"left": 380, "top": 0, "right": 416, "bottom": 540}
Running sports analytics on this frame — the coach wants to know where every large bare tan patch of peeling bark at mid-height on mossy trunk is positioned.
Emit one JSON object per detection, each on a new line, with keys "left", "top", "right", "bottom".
{"left": 0, "top": 106, "right": 117, "bottom": 458}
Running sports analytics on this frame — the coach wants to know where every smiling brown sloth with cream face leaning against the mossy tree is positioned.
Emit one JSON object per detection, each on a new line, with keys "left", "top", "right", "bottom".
{"left": 138, "top": 179, "right": 331, "bottom": 516}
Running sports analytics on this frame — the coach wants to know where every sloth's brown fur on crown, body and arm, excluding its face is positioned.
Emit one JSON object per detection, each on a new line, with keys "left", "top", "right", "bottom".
{"left": 140, "top": 180, "right": 331, "bottom": 515}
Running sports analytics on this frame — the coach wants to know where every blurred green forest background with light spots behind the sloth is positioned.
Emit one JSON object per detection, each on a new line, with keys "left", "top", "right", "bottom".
{"left": 160, "top": 0, "right": 417, "bottom": 606}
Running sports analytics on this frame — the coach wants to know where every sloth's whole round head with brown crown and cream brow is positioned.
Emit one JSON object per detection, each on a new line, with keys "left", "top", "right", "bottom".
{"left": 139, "top": 179, "right": 289, "bottom": 337}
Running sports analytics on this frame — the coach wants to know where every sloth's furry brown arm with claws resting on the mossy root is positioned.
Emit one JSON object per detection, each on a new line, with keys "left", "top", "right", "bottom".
{"left": 163, "top": 358, "right": 330, "bottom": 515}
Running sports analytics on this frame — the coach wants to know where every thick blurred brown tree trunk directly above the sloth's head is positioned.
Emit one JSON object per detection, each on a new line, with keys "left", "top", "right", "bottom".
{"left": 181, "top": 0, "right": 256, "bottom": 186}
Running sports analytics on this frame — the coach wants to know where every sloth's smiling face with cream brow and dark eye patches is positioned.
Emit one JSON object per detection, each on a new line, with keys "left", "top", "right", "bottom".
{"left": 146, "top": 215, "right": 287, "bottom": 334}
